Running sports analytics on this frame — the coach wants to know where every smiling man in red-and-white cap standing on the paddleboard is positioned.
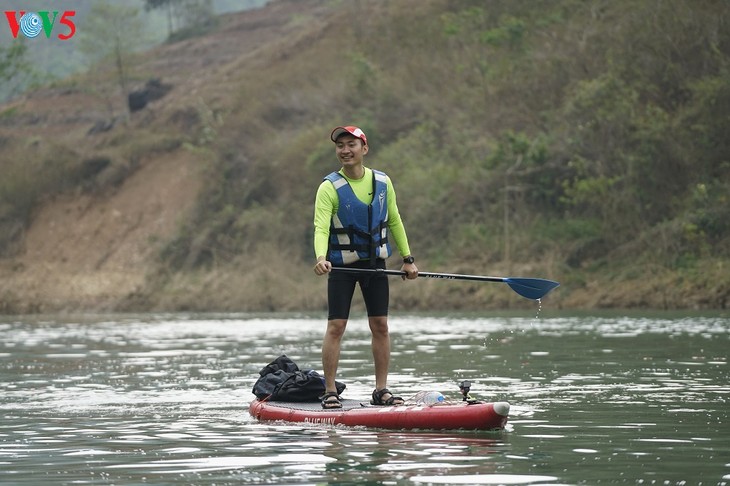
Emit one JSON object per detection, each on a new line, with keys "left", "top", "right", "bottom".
{"left": 314, "top": 126, "right": 418, "bottom": 408}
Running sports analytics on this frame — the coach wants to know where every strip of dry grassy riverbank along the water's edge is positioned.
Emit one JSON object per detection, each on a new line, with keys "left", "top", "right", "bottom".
{"left": 0, "top": 256, "right": 730, "bottom": 314}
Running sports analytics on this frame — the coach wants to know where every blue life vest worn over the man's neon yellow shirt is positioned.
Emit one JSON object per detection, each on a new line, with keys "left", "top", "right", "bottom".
{"left": 325, "top": 170, "right": 391, "bottom": 265}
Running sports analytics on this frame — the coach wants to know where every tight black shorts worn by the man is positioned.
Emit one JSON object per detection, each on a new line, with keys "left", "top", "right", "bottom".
{"left": 327, "top": 258, "right": 390, "bottom": 320}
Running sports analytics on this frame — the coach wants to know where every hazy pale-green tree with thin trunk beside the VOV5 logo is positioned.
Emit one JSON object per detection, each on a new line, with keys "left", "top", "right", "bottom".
{"left": 80, "top": 2, "right": 144, "bottom": 116}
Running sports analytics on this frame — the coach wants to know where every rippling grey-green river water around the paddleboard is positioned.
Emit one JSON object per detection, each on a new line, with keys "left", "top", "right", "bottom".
{"left": 0, "top": 311, "right": 730, "bottom": 485}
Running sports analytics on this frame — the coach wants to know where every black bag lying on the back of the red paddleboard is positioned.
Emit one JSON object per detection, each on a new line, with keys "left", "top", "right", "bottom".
{"left": 251, "top": 354, "right": 346, "bottom": 402}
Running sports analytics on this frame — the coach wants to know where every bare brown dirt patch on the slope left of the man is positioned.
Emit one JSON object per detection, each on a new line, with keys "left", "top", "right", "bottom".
{"left": 0, "top": 150, "right": 201, "bottom": 312}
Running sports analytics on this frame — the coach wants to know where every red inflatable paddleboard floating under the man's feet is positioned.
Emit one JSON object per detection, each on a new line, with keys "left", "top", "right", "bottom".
{"left": 248, "top": 399, "right": 509, "bottom": 430}
